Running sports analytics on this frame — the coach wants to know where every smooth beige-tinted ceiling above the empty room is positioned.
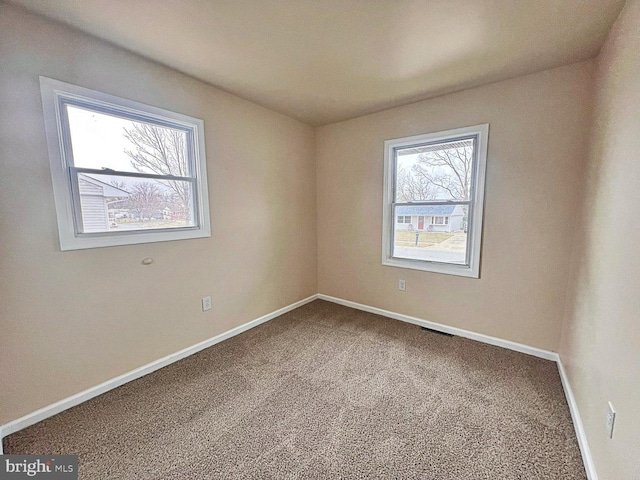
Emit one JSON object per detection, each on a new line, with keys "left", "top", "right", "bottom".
{"left": 11, "top": 0, "right": 624, "bottom": 125}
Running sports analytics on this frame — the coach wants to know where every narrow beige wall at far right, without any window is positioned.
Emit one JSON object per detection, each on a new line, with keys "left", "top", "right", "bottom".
{"left": 560, "top": 0, "right": 640, "bottom": 479}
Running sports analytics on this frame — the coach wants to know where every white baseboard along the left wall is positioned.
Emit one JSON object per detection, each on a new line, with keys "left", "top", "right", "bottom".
{"left": 0, "top": 295, "right": 318, "bottom": 455}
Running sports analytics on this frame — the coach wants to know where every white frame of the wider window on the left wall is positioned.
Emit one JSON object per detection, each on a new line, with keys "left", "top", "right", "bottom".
{"left": 40, "top": 77, "right": 211, "bottom": 251}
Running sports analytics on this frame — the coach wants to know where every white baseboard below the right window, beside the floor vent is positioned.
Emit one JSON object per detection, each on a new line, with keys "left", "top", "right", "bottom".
{"left": 318, "top": 294, "right": 558, "bottom": 361}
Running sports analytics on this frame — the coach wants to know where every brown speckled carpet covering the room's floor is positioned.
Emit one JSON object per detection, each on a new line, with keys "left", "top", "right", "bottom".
{"left": 4, "top": 300, "right": 586, "bottom": 480}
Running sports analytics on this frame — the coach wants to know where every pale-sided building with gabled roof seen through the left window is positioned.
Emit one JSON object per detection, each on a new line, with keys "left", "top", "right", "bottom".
{"left": 78, "top": 173, "right": 129, "bottom": 232}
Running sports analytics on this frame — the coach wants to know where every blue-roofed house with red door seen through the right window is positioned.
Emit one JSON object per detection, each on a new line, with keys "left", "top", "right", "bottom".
{"left": 396, "top": 205, "right": 464, "bottom": 232}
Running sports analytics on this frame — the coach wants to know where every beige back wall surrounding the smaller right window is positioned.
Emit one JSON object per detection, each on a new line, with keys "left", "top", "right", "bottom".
{"left": 316, "top": 62, "right": 593, "bottom": 351}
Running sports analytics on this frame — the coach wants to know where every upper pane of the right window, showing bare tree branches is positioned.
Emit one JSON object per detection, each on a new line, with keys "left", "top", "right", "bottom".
{"left": 395, "top": 138, "right": 474, "bottom": 202}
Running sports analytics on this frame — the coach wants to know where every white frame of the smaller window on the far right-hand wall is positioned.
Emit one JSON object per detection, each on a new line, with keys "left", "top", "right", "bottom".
{"left": 382, "top": 124, "right": 489, "bottom": 278}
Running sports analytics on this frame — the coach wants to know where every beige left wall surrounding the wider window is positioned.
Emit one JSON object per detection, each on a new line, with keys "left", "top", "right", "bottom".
{"left": 0, "top": 4, "right": 317, "bottom": 424}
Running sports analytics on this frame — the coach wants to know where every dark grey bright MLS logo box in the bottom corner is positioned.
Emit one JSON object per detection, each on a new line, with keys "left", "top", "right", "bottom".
{"left": 0, "top": 455, "right": 78, "bottom": 480}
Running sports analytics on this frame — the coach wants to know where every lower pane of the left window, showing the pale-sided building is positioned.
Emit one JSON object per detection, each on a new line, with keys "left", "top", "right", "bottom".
{"left": 78, "top": 173, "right": 196, "bottom": 233}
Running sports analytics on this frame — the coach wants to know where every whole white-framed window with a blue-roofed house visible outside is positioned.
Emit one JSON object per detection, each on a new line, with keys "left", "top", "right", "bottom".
{"left": 382, "top": 124, "right": 489, "bottom": 278}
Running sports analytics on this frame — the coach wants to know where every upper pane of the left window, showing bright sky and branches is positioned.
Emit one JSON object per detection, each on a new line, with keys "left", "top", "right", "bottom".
{"left": 67, "top": 105, "right": 191, "bottom": 176}
